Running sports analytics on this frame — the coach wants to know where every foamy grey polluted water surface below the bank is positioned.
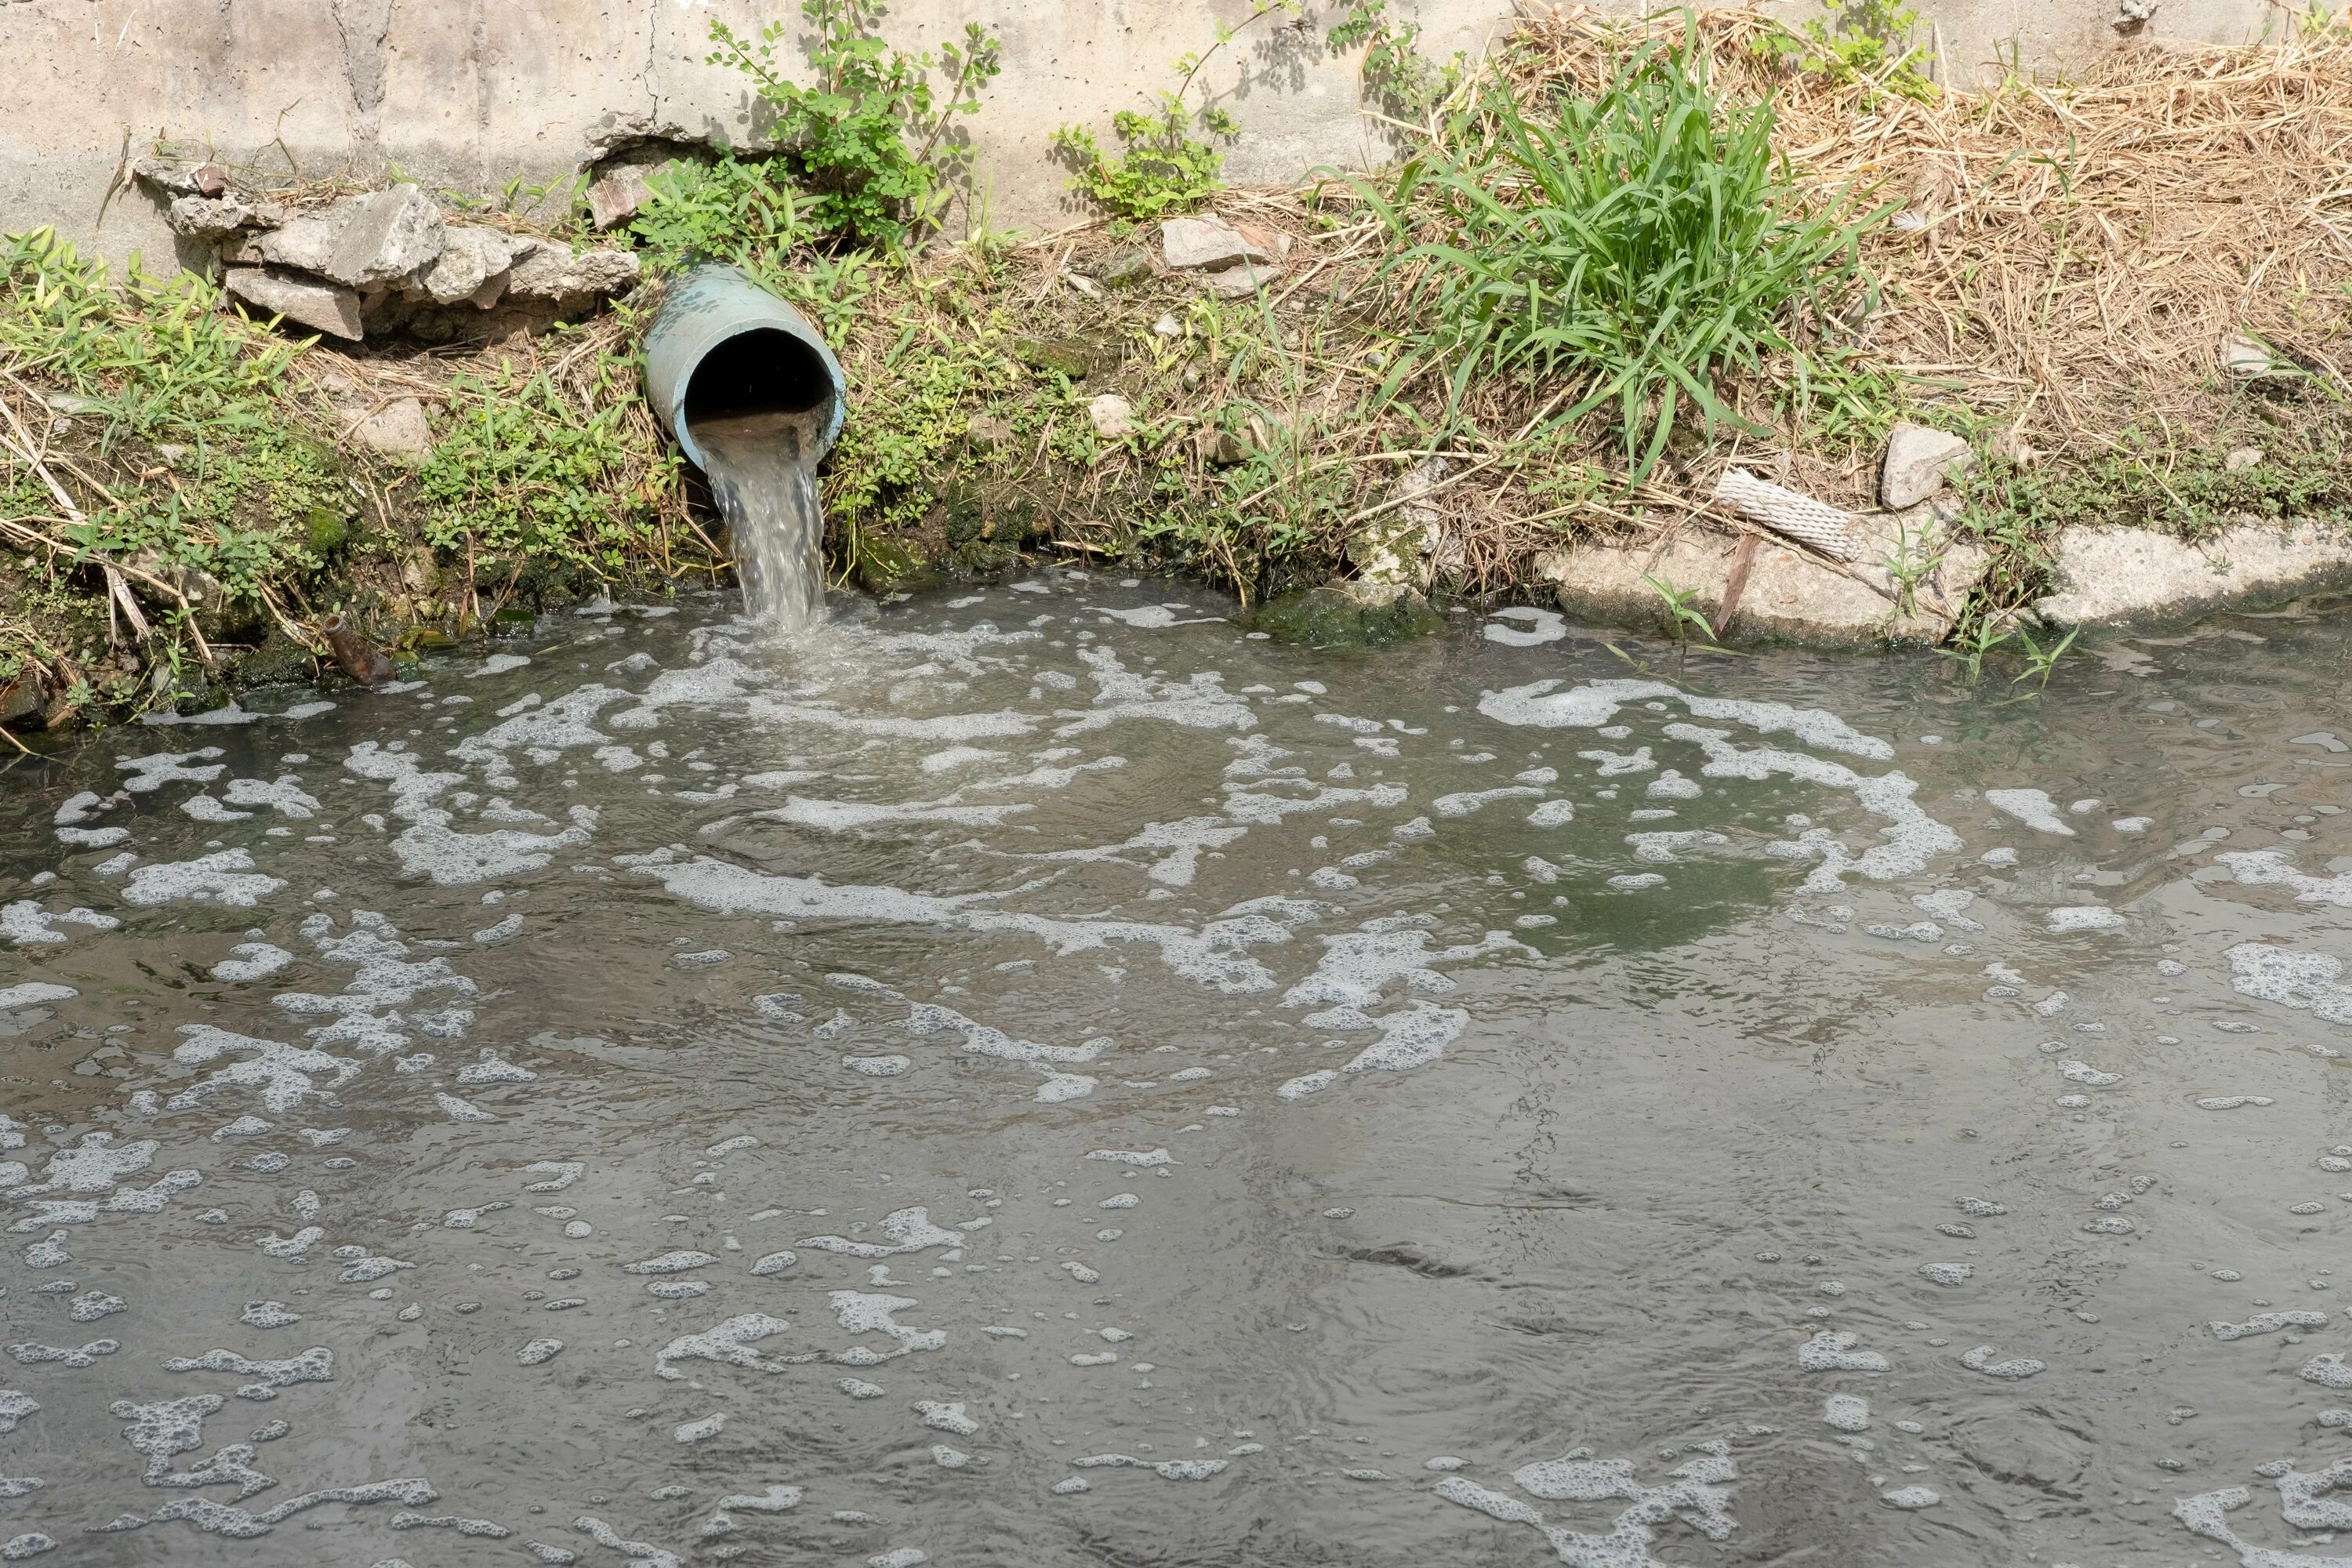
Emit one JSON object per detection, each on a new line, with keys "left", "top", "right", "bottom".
{"left": 0, "top": 574, "right": 2352, "bottom": 1568}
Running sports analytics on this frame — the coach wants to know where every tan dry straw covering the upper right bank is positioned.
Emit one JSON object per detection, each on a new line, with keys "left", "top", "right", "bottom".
{"left": 1512, "top": 9, "right": 2352, "bottom": 472}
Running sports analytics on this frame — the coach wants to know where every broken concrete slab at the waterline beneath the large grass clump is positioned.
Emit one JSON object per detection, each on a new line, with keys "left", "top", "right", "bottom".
{"left": 1536, "top": 508, "right": 1985, "bottom": 647}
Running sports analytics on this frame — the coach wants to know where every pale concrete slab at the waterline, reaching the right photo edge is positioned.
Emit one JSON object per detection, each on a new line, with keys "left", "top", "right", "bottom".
{"left": 2032, "top": 520, "right": 2352, "bottom": 626}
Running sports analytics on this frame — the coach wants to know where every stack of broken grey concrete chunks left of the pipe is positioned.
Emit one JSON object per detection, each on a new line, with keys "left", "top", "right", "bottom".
{"left": 132, "top": 160, "right": 642, "bottom": 343}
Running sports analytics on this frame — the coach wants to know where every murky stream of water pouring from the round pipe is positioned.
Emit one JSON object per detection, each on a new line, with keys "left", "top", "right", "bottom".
{"left": 694, "top": 405, "right": 830, "bottom": 633}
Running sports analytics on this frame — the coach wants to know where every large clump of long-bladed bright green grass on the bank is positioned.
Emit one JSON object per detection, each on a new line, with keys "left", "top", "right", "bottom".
{"left": 1359, "top": 28, "right": 1886, "bottom": 480}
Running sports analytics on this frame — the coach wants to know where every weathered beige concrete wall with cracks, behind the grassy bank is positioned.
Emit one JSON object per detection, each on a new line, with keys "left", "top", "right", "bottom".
{"left": 0, "top": 0, "right": 2277, "bottom": 268}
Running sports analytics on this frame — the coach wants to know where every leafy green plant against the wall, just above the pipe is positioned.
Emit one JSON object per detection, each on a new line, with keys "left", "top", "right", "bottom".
{"left": 708, "top": 0, "right": 1002, "bottom": 249}
